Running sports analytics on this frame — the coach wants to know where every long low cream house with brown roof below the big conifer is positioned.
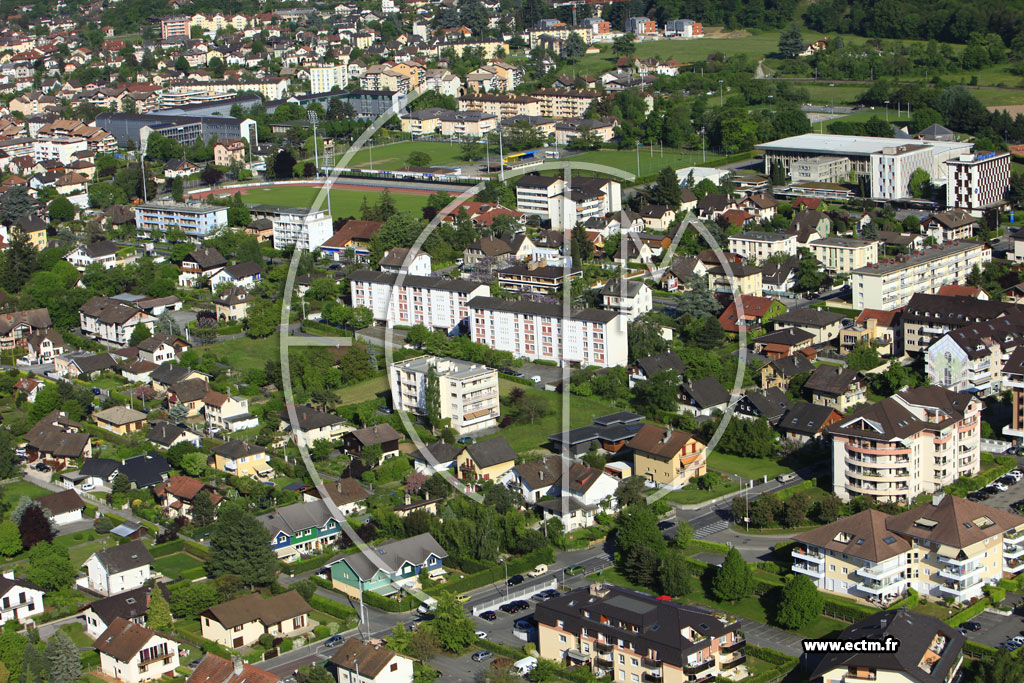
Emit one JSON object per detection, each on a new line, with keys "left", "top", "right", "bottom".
{"left": 199, "top": 591, "right": 311, "bottom": 649}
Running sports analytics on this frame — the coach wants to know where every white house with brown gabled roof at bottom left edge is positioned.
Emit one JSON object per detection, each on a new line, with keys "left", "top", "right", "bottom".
{"left": 92, "top": 618, "right": 180, "bottom": 683}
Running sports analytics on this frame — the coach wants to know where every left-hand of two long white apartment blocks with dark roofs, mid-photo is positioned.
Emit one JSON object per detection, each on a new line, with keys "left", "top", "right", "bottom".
{"left": 348, "top": 270, "right": 490, "bottom": 333}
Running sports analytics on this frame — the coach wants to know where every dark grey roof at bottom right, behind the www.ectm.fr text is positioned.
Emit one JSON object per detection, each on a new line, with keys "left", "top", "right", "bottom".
{"left": 811, "top": 609, "right": 967, "bottom": 683}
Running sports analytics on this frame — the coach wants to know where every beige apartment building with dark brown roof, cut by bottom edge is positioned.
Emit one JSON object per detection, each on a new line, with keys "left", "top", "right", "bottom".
{"left": 536, "top": 584, "right": 746, "bottom": 683}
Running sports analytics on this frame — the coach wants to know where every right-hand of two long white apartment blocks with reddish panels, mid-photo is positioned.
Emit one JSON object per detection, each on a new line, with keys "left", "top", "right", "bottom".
{"left": 469, "top": 296, "right": 629, "bottom": 368}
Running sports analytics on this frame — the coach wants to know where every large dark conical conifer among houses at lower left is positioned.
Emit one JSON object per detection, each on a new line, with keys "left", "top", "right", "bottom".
{"left": 206, "top": 505, "right": 278, "bottom": 586}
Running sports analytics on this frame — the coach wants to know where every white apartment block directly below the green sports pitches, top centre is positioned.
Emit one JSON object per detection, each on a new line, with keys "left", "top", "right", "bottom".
{"left": 515, "top": 173, "right": 623, "bottom": 229}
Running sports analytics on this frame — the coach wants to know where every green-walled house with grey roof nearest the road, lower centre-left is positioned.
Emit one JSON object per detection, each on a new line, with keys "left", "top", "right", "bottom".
{"left": 328, "top": 533, "right": 447, "bottom": 597}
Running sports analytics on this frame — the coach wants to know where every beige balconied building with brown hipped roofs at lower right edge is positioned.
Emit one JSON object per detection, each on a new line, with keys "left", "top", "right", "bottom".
{"left": 793, "top": 492, "right": 1024, "bottom": 604}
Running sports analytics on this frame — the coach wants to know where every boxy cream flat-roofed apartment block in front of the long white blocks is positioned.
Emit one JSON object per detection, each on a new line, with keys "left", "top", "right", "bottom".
{"left": 391, "top": 355, "right": 501, "bottom": 434}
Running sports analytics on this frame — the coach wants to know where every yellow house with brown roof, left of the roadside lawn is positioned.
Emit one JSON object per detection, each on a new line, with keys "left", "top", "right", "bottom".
{"left": 629, "top": 424, "right": 708, "bottom": 487}
